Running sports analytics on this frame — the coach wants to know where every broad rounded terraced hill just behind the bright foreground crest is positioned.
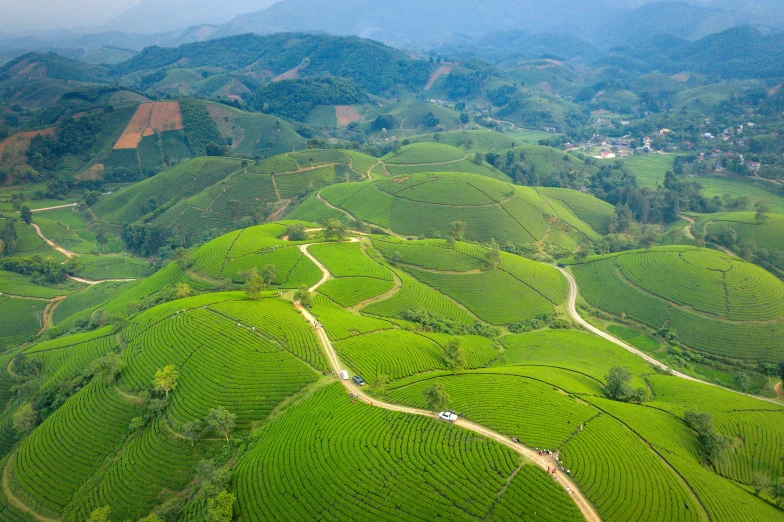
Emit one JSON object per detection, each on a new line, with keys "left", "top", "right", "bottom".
{"left": 321, "top": 169, "right": 599, "bottom": 246}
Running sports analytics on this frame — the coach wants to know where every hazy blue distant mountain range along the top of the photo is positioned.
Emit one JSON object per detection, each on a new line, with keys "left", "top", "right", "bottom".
{"left": 0, "top": 0, "right": 784, "bottom": 67}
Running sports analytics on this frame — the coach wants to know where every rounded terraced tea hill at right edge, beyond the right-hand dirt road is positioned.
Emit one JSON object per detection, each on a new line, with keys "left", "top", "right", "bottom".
{"left": 573, "top": 247, "right": 784, "bottom": 362}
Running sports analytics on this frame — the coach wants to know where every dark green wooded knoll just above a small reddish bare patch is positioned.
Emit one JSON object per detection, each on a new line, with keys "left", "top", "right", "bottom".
{"left": 250, "top": 78, "right": 365, "bottom": 121}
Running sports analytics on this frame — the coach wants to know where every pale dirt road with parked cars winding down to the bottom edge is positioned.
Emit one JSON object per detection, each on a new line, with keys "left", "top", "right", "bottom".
{"left": 295, "top": 245, "right": 601, "bottom": 522}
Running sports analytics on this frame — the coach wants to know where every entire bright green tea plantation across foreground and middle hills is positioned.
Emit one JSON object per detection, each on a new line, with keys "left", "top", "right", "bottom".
{"left": 0, "top": 147, "right": 784, "bottom": 522}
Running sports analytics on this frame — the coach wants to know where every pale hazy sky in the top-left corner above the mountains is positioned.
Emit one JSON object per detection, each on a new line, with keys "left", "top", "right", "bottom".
{"left": 0, "top": 0, "right": 140, "bottom": 33}
